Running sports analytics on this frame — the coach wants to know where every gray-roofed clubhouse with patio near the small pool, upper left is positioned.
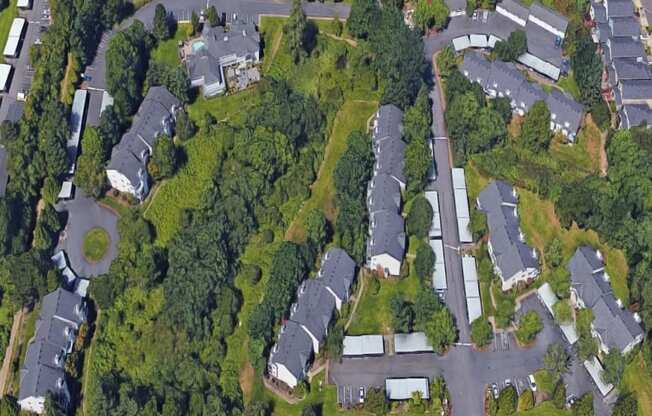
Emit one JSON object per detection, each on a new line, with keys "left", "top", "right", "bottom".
{"left": 185, "top": 22, "right": 260, "bottom": 97}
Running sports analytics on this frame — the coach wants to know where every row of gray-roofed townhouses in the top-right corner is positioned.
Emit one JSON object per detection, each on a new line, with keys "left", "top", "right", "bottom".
{"left": 590, "top": 0, "right": 652, "bottom": 128}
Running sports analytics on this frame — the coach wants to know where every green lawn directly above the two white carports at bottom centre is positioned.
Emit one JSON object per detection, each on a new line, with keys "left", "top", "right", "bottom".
{"left": 347, "top": 274, "right": 420, "bottom": 335}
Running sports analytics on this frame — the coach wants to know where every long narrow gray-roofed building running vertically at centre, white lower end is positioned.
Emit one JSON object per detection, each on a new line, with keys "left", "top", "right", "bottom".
{"left": 367, "top": 104, "right": 406, "bottom": 276}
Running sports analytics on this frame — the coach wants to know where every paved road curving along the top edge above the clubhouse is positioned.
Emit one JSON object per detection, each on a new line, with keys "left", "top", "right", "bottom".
{"left": 85, "top": 0, "right": 350, "bottom": 90}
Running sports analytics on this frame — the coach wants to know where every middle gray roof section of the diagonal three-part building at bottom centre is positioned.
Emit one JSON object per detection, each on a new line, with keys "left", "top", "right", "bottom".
{"left": 290, "top": 279, "right": 335, "bottom": 343}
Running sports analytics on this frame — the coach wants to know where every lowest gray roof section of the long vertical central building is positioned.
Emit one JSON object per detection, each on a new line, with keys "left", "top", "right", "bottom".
{"left": 367, "top": 211, "right": 405, "bottom": 261}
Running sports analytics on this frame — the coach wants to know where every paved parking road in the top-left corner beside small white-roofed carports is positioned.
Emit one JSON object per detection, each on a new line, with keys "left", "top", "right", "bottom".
{"left": 0, "top": 0, "right": 49, "bottom": 120}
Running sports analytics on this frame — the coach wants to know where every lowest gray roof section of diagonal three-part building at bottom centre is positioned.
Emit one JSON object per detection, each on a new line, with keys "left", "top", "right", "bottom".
{"left": 269, "top": 321, "right": 313, "bottom": 379}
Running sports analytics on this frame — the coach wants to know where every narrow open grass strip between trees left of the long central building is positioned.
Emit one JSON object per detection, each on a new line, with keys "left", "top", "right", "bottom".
{"left": 286, "top": 101, "right": 378, "bottom": 241}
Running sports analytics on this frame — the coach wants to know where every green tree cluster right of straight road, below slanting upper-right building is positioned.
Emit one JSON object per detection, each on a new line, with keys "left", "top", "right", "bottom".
{"left": 445, "top": 68, "right": 509, "bottom": 162}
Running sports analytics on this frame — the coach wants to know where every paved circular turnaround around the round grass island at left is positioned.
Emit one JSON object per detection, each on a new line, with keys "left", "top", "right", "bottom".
{"left": 55, "top": 188, "right": 120, "bottom": 278}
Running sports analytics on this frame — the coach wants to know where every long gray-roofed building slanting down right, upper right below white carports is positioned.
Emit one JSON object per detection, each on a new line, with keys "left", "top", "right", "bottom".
{"left": 460, "top": 51, "right": 584, "bottom": 142}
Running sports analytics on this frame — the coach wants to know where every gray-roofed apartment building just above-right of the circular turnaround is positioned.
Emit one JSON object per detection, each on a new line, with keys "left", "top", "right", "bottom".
{"left": 106, "top": 87, "right": 181, "bottom": 201}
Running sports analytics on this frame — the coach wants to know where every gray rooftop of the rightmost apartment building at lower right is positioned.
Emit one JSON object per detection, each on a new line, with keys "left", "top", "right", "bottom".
{"left": 567, "top": 246, "right": 643, "bottom": 351}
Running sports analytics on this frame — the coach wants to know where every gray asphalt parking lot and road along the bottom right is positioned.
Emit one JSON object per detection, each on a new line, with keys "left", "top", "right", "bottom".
{"left": 329, "top": 296, "right": 610, "bottom": 416}
